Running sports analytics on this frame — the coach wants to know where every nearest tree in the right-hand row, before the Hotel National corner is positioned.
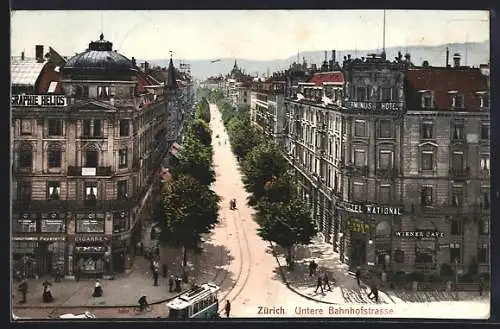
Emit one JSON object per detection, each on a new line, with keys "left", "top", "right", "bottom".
{"left": 256, "top": 197, "right": 317, "bottom": 269}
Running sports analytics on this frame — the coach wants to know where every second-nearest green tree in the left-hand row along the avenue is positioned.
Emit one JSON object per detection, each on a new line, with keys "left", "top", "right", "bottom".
{"left": 171, "top": 134, "right": 215, "bottom": 185}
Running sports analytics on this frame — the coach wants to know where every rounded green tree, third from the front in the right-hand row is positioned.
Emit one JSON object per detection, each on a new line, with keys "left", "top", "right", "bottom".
{"left": 243, "top": 143, "right": 288, "bottom": 206}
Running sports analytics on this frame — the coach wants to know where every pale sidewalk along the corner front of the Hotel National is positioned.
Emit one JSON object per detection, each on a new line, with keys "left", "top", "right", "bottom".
{"left": 274, "top": 234, "right": 489, "bottom": 304}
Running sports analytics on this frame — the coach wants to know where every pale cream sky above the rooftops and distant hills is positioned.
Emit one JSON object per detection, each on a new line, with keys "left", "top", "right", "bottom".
{"left": 11, "top": 10, "right": 490, "bottom": 60}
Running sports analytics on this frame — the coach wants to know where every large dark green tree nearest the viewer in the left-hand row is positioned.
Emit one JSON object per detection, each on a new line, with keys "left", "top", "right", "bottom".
{"left": 160, "top": 175, "right": 220, "bottom": 268}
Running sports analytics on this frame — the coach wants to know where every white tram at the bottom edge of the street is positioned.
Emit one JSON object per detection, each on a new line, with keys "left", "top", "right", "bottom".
{"left": 166, "top": 283, "right": 220, "bottom": 320}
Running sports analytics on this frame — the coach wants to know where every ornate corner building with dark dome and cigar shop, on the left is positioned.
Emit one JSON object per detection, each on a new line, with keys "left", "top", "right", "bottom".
{"left": 12, "top": 34, "right": 167, "bottom": 277}
